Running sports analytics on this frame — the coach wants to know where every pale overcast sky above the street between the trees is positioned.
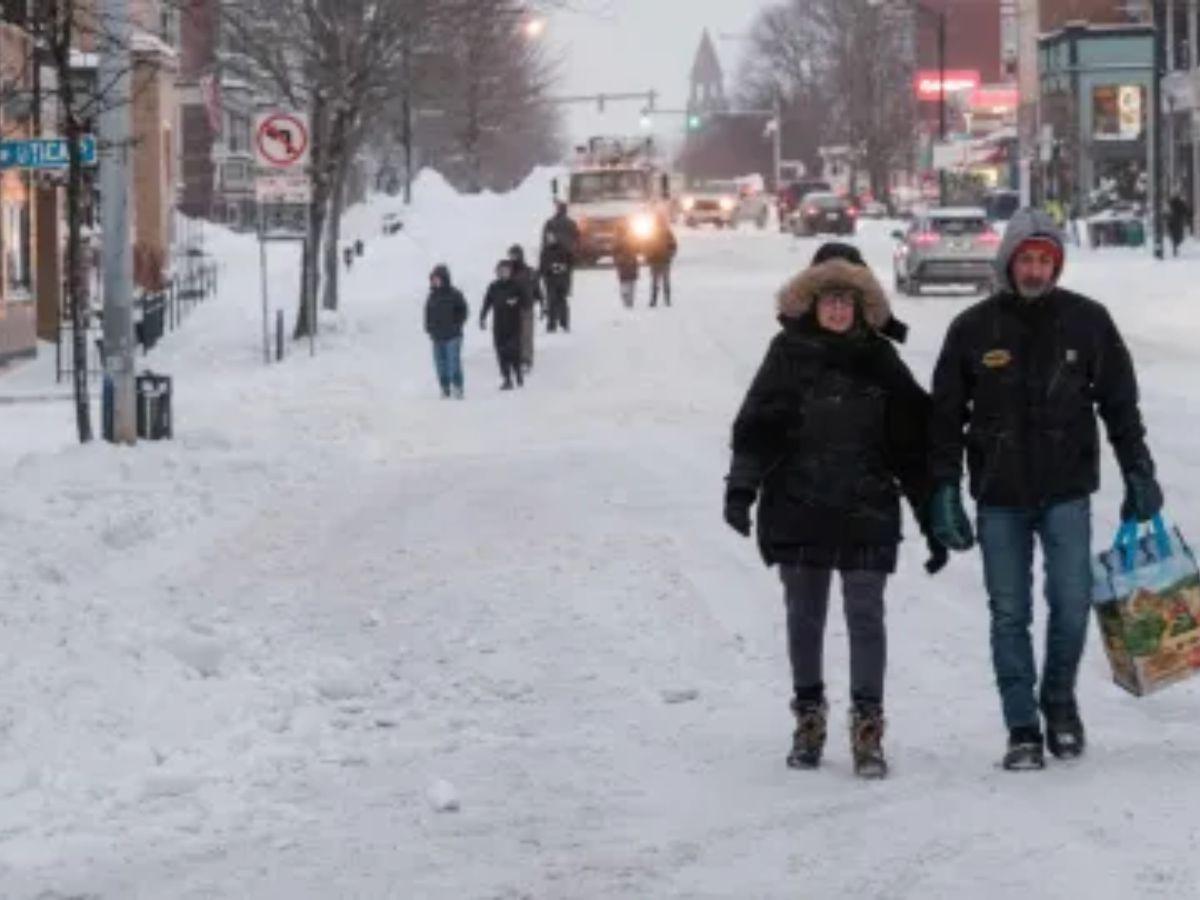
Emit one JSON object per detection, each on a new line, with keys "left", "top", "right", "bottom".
{"left": 546, "top": 0, "right": 778, "bottom": 142}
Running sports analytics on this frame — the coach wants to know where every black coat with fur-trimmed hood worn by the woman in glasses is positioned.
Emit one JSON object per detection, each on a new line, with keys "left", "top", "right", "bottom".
{"left": 727, "top": 260, "right": 930, "bottom": 571}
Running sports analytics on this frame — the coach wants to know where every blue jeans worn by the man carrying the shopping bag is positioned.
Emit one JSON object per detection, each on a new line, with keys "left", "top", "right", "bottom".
{"left": 979, "top": 498, "right": 1092, "bottom": 728}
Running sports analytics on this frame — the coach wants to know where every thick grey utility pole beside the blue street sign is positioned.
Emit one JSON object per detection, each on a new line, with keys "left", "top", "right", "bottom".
{"left": 97, "top": 0, "right": 138, "bottom": 444}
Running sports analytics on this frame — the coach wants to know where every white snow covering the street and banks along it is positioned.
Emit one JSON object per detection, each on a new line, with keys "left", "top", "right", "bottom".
{"left": 0, "top": 173, "right": 1200, "bottom": 900}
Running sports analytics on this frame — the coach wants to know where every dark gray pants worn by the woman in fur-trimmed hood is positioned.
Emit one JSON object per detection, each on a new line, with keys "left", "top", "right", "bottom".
{"left": 780, "top": 565, "right": 888, "bottom": 703}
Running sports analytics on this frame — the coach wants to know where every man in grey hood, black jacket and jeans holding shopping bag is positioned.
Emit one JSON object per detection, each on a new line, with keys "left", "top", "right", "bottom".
{"left": 930, "top": 210, "right": 1163, "bottom": 769}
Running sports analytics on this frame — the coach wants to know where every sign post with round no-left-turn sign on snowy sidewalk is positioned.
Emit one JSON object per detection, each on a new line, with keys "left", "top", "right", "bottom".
{"left": 254, "top": 110, "right": 317, "bottom": 365}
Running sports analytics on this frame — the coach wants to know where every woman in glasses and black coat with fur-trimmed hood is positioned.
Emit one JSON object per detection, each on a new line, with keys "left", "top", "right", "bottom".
{"left": 725, "top": 247, "right": 946, "bottom": 776}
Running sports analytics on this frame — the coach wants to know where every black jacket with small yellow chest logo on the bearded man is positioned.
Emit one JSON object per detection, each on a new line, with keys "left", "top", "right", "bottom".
{"left": 931, "top": 288, "right": 1153, "bottom": 509}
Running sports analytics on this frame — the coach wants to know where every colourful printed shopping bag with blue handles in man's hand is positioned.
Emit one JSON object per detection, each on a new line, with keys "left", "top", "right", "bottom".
{"left": 1092, "top": 516, "right": 1200, "bottom": 697}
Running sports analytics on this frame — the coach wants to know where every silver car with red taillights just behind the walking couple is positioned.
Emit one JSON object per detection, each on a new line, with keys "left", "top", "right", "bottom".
{"left": 892, "top": 206, "right": 1001, "bottom": 296}
